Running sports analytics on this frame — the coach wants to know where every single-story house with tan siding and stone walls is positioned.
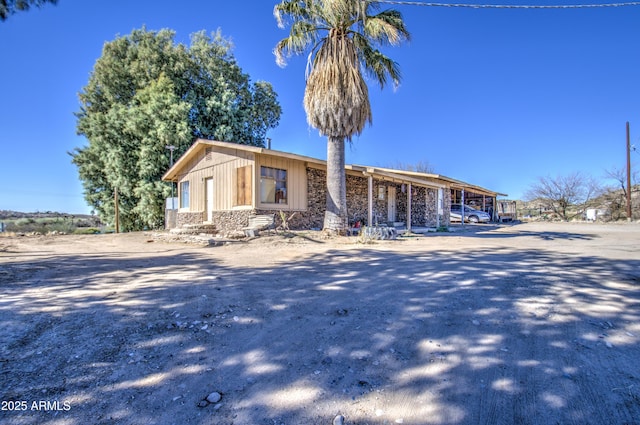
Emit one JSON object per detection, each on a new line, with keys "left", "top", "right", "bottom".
{"left": 163, "top": 139, "right": 501, "bottom": 233}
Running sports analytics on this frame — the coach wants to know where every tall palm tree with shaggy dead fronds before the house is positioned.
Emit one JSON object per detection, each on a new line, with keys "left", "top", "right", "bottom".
{"left": 274, "top": 0, "right": 410, "bottom": 233}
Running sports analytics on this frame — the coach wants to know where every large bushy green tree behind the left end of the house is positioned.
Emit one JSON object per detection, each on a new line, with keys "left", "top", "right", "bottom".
{"left": 71, "top": 28, "right": 281, "bottom": 230}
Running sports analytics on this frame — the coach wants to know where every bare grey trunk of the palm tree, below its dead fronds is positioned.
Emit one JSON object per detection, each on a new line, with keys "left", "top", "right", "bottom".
{"left": 324, "top": 136, "right": 347, "bottom": 234}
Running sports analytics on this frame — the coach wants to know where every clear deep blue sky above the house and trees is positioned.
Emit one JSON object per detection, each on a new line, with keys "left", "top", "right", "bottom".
{"left": 0, "top": 0, "right": 640, "bottom": 213}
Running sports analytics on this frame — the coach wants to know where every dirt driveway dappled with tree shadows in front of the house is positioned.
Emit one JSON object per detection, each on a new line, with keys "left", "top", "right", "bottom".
{"left": 0, "top": 224, "right": 640, "bottom": 425}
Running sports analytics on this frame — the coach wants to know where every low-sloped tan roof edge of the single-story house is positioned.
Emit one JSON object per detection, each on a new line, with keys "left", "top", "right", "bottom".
{"left": 162, "top": 139, "right": 507, "bottom": 196}
